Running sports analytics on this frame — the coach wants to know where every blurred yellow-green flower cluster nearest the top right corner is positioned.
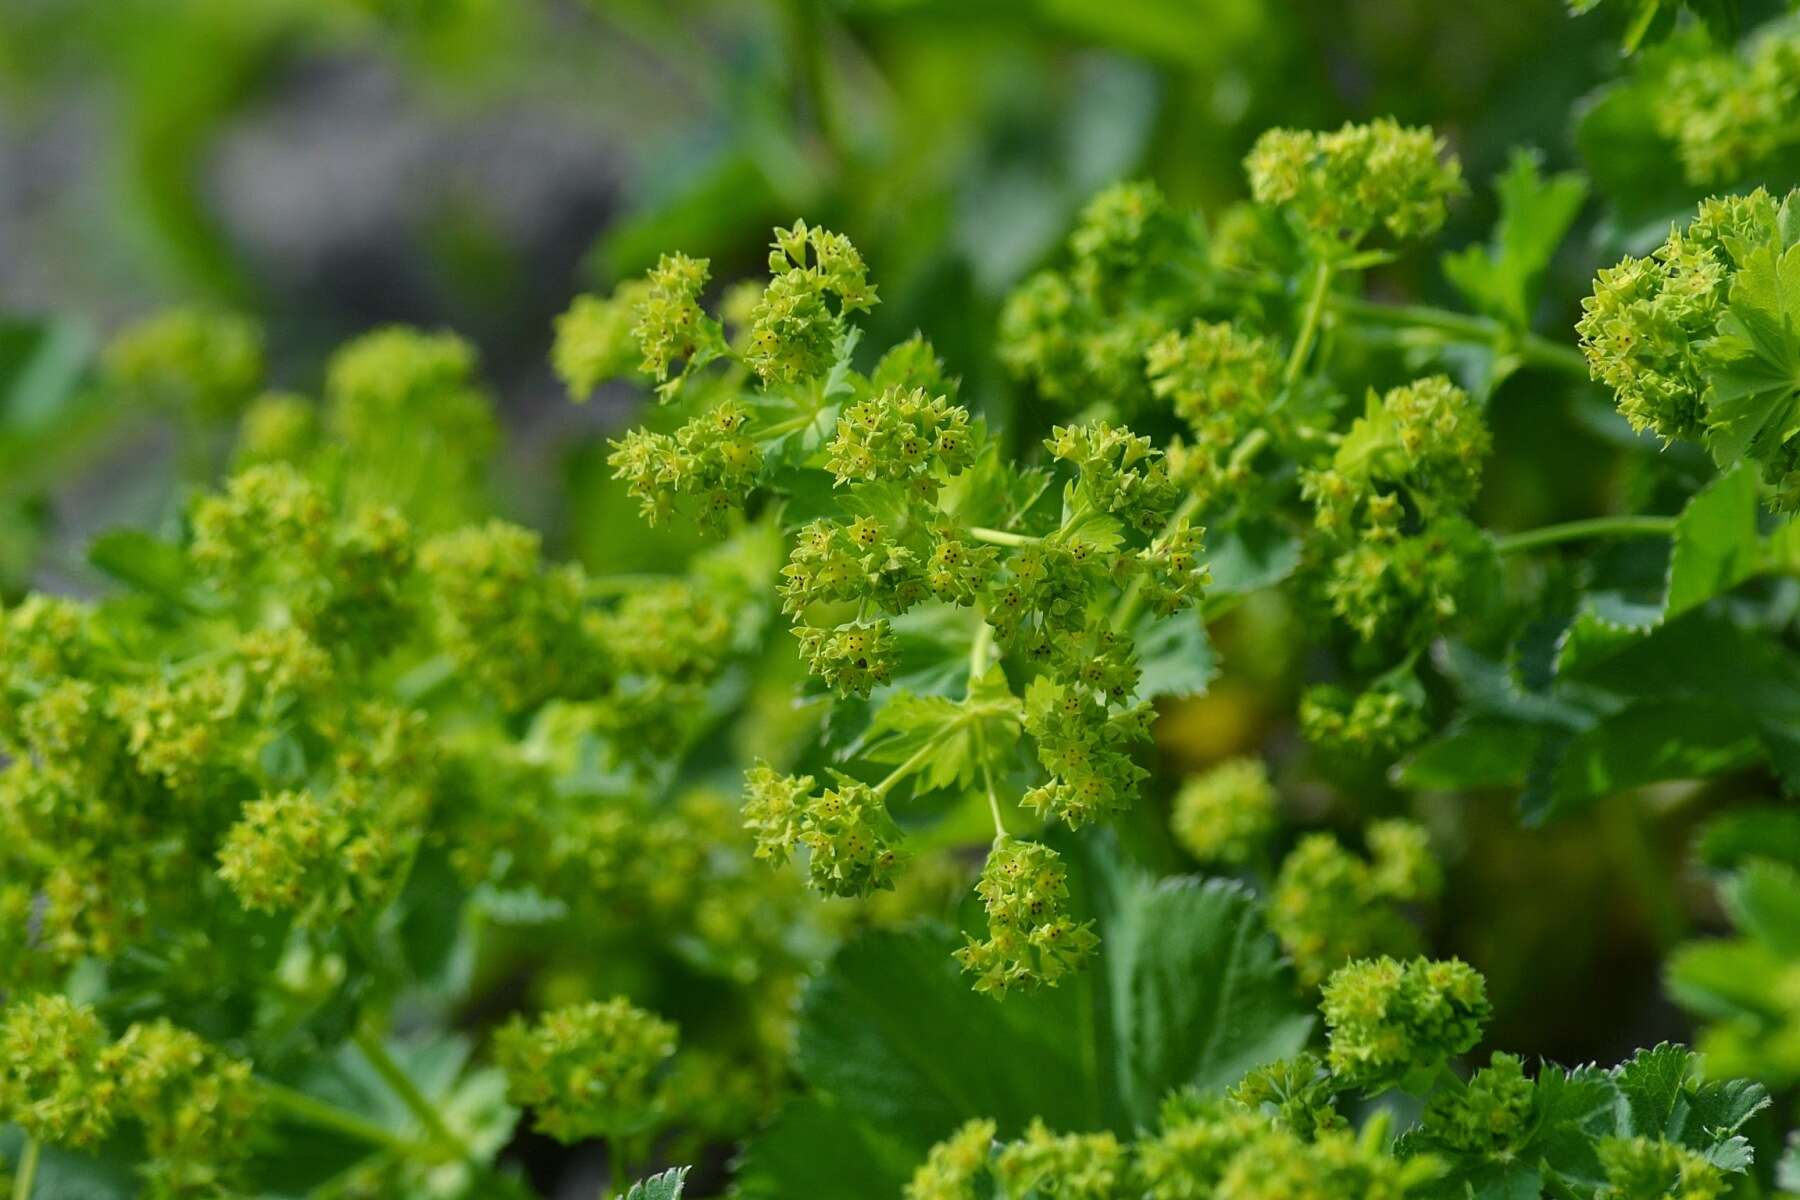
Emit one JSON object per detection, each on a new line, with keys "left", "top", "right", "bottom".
{"left": 1656, "top": 23, "right": 1800, "bottom": 187}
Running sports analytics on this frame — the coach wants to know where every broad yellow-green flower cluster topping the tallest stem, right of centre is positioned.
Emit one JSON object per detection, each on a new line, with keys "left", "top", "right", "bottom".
{"left": 1244, "top": 117, "right": 1463, "bottom": 255}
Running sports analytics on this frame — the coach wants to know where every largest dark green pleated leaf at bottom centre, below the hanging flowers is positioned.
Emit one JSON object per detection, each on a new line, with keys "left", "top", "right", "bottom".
{"left": 740, "top": 842, "right": 1312, "bottom": 1196}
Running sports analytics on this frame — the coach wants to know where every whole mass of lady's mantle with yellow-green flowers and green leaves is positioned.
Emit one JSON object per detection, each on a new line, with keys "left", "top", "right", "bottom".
{"left": 0, "top": 4, "right": 1800, "bottom": 1200}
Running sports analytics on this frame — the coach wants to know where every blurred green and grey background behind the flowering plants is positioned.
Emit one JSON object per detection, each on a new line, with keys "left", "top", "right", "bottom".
{"left": 0, "top": 0, "right": 1728, "bottom": 1079}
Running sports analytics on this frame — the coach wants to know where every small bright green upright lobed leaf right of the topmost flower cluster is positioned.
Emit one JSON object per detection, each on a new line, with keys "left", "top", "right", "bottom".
{"left": 1444, "top": 148, "right": 1588, "bottom": 329}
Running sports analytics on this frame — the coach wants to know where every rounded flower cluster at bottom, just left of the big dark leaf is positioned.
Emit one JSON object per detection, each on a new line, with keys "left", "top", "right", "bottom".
{"left": 493, "top": 997, "right": 675, "bottom": 1142}
